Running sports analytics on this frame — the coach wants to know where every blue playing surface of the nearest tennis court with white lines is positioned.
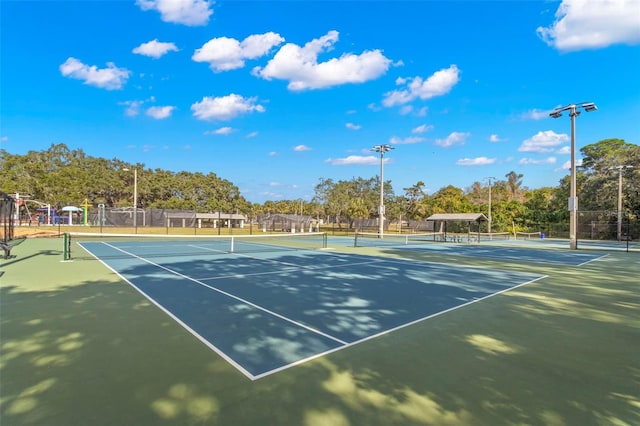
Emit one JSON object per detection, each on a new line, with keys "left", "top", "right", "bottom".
{"left": 81, "top": 242, "right": 543, "bottom": 379}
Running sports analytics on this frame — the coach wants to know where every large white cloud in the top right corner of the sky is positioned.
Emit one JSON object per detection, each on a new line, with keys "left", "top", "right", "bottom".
{"left": 536, "top": 0, "right": 640, "bottom": 51}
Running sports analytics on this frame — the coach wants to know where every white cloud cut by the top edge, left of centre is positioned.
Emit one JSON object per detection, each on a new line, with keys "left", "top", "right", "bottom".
{"left": 136, "top": 0, "right": 213, "bottom": 26}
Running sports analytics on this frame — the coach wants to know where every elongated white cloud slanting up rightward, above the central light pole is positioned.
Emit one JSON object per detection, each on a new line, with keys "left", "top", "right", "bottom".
{"left": 382, "top": 65, "right": 460, "bottom": 107}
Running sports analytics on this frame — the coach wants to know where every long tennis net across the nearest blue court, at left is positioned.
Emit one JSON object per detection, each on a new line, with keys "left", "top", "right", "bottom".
{"left": 65, "top": 232, "right": 327, "bottom": 259}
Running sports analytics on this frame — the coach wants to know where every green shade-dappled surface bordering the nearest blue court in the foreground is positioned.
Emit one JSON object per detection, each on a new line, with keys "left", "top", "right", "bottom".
{"left": 0, "top": 238, "right": 640, "bottom": 426}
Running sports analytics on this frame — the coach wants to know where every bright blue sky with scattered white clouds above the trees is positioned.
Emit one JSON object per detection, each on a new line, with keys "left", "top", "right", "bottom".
{"left": 0, "top": 0, "right": 640, "bottom": 202}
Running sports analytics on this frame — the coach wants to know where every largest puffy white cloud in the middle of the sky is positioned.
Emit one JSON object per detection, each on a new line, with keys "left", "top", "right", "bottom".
{"left": 253, "top": 31, "right": 391, "bottom": 91}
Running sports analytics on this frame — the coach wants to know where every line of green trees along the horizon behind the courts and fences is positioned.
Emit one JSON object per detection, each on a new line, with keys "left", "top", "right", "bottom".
{"left": 0, "top": 139, "right": 640, "bottom": 231}
